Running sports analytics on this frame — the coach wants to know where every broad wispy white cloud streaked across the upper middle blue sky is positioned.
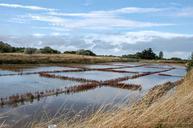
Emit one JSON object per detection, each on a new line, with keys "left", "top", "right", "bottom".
{"left": 26, "top": 14, "right": 172, "bottom": 29}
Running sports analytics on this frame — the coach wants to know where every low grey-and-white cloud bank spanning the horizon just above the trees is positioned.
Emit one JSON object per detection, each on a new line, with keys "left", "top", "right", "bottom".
{"left": 0, "top": 31, "right": 193, "bottom": 58}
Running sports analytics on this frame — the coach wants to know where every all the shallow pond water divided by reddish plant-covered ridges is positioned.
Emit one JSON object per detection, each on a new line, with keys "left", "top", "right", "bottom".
{"left": 0, "top": 63, "right": 186, "bottom": 128}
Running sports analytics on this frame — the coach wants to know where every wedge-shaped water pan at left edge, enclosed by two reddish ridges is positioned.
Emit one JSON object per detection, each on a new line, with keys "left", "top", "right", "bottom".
{"left": 0, "top": 74, "right": 80, "bottom": 97}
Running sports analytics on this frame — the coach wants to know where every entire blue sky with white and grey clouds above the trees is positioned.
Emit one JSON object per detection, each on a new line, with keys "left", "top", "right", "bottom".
{"left": 0, "top": 0, "right": 193, "bottom": 58}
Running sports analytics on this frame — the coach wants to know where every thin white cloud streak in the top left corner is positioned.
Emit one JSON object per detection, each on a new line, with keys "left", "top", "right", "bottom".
{"left": 0, "top": 3, "right": 56, "bottom": 11}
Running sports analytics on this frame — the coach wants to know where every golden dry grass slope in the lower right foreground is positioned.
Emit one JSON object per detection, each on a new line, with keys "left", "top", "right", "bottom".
{"left": 35, "top": 70, "right": 193, "bottom": 128}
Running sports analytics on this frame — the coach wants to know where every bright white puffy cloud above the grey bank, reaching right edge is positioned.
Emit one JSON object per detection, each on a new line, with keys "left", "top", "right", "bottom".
{"left": 86, "top": 31, "right": 193, "bottom": 45}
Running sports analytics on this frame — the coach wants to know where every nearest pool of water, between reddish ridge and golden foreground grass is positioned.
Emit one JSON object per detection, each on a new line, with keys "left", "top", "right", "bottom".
{"left": 0, "top": 87, "right": 141, "bottom": 127}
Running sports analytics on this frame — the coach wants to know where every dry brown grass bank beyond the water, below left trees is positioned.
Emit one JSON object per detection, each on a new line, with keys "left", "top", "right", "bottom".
{"left": 0, "top": 53, "right": 133, "bottom": 64}
